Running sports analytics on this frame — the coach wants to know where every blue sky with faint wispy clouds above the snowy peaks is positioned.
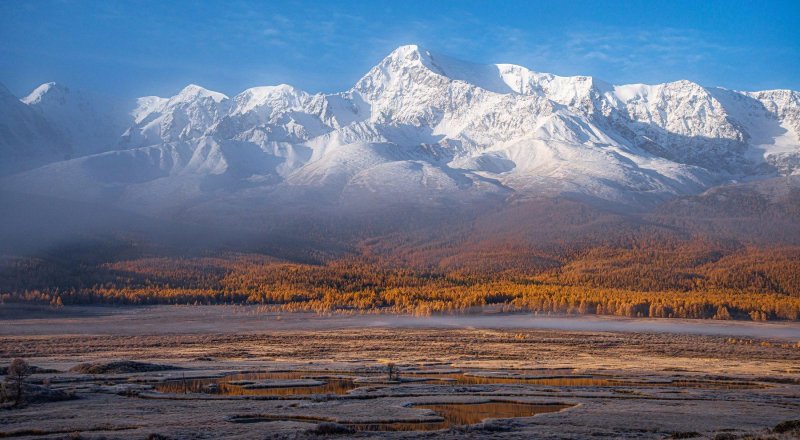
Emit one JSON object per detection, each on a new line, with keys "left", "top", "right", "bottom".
{"left": 0, "top": 0, "right": 800, "bottom": 97}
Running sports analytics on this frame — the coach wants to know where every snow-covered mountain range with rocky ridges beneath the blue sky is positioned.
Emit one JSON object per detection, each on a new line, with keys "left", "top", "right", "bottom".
{"left": 0, "top": 46, "right": 800, "bottom": 217}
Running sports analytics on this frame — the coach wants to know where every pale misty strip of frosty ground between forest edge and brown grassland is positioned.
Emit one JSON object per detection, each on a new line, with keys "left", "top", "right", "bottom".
{"left": 6, "top": 304, "right": 800, "bottom": 341}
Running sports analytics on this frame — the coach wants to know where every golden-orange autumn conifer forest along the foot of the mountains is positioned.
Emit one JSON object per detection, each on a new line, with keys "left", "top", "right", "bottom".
{"left": 0, "top": 241, "right": 800, "bottom": 321}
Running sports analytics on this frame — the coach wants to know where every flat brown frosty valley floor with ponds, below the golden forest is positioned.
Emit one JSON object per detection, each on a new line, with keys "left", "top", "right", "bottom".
{"left": 0, "top": 305, "right": 800, "bottom": 439}
